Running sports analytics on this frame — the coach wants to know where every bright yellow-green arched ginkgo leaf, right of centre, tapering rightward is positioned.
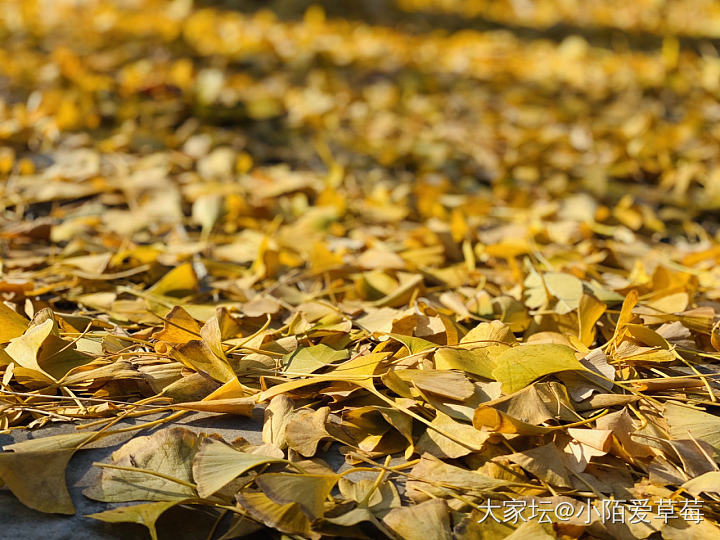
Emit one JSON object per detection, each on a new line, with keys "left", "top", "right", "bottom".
{"left": 492, "top": 343, "right": 586, "bottom": 393}
